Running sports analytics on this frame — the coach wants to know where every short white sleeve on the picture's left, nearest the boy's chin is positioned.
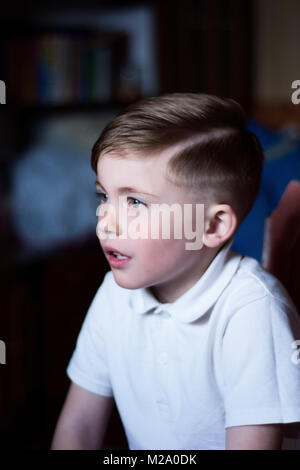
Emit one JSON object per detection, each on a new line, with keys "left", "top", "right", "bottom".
{"left": 67, "top": 272, "right": 113, "bottom": 396}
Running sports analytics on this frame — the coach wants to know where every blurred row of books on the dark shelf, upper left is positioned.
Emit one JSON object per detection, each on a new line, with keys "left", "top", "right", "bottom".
{"left": 1, "top": 27, "right": 135, "bottom": 109}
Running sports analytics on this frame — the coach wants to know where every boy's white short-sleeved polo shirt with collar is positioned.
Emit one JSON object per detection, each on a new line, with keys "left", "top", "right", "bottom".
{"left": 67, "top": 239, "right": 300, "bottom": 450}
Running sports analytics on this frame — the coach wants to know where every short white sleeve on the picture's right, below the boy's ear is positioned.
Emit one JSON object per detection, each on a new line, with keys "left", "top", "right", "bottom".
{"left": 221, "top": 293, "right": 300, "bottom": 434}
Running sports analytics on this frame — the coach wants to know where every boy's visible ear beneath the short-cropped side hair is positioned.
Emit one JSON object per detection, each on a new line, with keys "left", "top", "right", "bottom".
{"left": 203, "top": 204, "right": 238, "bottom": 248}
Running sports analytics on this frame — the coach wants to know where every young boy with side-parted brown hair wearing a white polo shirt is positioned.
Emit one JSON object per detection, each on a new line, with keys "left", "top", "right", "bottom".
{"left": 52, "top": 93, "right": 300, "bottom": 450}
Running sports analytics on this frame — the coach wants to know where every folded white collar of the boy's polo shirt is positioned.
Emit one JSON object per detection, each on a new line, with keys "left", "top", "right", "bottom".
{"left": 130, "top": 238, "right": 242, "bottom": 323}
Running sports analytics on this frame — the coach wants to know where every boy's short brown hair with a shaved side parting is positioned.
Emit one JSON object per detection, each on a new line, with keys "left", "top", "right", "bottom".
{"left": 91, "top": 93, "right": 264, "bottom": 225}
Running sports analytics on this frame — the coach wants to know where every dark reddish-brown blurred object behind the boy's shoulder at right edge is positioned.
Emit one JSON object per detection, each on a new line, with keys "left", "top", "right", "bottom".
{"left": 262, "top": 180, "right": 300, "bottom": 315}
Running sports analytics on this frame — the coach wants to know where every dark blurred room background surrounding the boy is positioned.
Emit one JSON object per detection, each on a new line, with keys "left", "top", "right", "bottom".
{"left": 0, "top": 0, "right": 300, "bottom": 449}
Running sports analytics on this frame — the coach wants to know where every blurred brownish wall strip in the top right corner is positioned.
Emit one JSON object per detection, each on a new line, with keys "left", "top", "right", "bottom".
{"left": 254, "top": 0, "right": 300, "bottom": 103}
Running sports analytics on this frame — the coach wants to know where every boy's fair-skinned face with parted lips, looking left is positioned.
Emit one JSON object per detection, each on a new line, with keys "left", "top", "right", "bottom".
{"left": 96, "top": 148, "right": 213, "bottom": 302}
